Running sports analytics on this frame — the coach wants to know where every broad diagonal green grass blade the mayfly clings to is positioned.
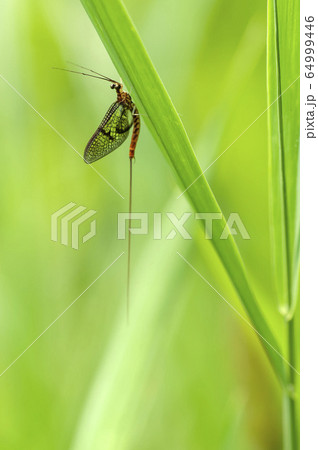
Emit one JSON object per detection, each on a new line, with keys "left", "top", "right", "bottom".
{"left": 82, "top": 0, "right": 285, "bottom": 384}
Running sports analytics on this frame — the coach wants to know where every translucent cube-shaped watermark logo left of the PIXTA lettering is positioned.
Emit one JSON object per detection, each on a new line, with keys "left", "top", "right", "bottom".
{"left": 51, "top": 202, "right": 96, "bottom": 250}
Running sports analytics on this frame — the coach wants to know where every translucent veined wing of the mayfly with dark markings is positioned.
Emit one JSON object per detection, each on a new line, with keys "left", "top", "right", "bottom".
{"left": 84, "top": 102, "right": 133, "bottom": 164}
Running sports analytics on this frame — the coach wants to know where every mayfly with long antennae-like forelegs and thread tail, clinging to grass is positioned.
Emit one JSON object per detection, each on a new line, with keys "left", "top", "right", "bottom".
{"left": 54, "top": 66, "right": 140, "bottom": 317}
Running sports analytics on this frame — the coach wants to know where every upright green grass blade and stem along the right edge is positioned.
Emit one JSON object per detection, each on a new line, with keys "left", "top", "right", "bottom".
{"left": 267, "top": 0, "right": 299, "bottom": 450}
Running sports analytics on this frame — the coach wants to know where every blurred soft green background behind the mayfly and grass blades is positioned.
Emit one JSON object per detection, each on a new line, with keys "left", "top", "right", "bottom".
{"left": 0, "top": 0, "right": 296, "bottom": 450}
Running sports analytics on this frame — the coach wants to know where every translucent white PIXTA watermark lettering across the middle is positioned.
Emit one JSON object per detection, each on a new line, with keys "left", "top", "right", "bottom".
{"left": 117, "top": 212, "right": 250, "bottom": 240}
